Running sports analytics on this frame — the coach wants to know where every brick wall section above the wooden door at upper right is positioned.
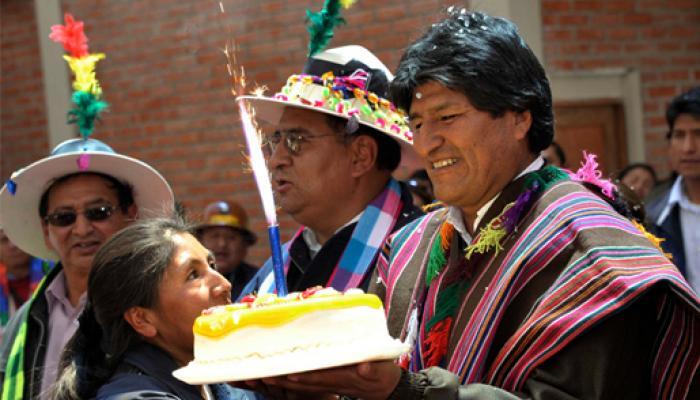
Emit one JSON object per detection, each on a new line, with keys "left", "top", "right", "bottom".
{"left": 542, "top": 0, "right": 700, "bottom": 177}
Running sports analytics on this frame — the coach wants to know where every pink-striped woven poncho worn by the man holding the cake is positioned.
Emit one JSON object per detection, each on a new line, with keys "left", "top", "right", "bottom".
{"left": 377, "top": 182, "right": 700, "bottom": 398}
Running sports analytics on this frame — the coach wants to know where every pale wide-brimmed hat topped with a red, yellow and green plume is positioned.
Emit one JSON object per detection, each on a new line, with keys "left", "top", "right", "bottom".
{"left": 0, "top": 14, "right": 174, "bottom": 260}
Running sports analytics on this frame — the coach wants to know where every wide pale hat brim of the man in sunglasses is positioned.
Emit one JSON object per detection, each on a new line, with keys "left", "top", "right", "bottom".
{"left": 0, "top": 151, "right": 174, "bottom": 260}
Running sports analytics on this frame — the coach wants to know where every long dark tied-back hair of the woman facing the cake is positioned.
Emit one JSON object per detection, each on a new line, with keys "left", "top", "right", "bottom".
{"left": 53, "top": 218, "right": 190, "bottom": 399}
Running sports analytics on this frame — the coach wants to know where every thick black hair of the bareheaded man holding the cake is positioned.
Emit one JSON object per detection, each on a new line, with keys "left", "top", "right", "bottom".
{"left": 390, "top": 7, "right": 554, "bottom": 154}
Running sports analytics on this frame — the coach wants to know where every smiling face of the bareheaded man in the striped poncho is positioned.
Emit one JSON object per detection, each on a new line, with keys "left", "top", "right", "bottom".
{"left": 409, "top": 81, "right": 535, "bottom": 220}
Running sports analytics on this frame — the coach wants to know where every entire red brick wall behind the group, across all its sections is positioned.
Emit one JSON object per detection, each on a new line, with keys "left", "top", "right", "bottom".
{"left": 5, "top": 0, "right": 700, "bottom": 262}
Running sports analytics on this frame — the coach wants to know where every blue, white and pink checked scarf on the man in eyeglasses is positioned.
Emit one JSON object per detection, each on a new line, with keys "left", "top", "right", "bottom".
{"left": 258, "top": 179, "right": 402, "bottom": 293}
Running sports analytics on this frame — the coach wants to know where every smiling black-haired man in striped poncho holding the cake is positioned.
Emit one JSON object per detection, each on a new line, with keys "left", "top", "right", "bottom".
{"left": 250, "top": 9, "right": 700, "bottom": 399}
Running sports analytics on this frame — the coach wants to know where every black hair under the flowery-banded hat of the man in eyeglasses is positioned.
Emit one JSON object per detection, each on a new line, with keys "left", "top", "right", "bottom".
{"left": 326, "top": 115, "right": 401, "bottom": 172}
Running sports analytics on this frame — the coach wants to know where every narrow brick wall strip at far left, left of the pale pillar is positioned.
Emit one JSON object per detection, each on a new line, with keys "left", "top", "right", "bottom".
{"left": 0, "top": 0, "right": 48, "bottom": 182}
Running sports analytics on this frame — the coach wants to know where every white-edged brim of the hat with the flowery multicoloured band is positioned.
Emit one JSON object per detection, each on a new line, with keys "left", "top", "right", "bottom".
{"left": 236, "top": 96, "right": 413, "bottom": 151}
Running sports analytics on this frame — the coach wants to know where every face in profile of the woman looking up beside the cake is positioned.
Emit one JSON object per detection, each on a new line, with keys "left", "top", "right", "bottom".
{"left": 146, "top": 233, "right": 231, "bottom": 365}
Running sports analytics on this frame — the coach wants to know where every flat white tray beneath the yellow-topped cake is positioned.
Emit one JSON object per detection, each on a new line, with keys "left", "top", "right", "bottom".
{"left": 173, "top": 340, "right": 408, "bottom": 385}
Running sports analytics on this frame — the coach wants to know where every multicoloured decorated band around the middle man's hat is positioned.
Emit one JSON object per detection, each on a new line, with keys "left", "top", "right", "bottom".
{"left": 274, "top": 70, "right": 413, "bottom": 143}
